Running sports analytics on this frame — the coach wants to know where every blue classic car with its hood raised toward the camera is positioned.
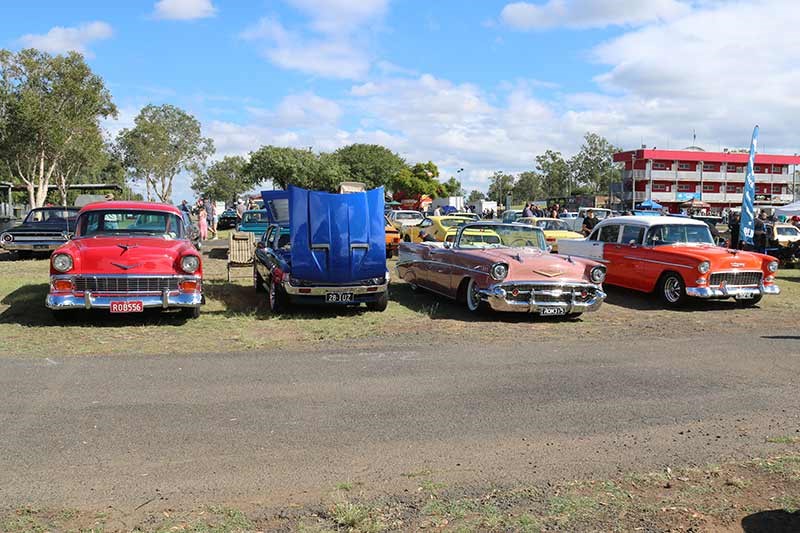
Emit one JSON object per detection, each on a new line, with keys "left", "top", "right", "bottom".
{"left": 253, "top": 186, "right": 389, "bottom": 313}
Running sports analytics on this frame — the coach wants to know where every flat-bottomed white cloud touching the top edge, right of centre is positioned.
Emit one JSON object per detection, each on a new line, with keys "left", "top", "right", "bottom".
{"left": 500, "top": 0, "right": 690, "bottom": 30}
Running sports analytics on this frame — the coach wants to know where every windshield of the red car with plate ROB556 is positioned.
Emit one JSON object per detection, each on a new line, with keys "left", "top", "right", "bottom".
{"left": 76, "top": 209, "right": 183, "bottom": 239}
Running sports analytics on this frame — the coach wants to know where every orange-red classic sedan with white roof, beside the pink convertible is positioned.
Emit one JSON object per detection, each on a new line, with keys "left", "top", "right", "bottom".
{"left": 558, "top": 216, "right": 780, "bottom": 306}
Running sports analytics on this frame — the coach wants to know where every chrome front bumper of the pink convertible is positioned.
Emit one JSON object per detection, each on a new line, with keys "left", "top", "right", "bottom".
{"left": 479, "top": 281, "right": 606, "bottom": 314}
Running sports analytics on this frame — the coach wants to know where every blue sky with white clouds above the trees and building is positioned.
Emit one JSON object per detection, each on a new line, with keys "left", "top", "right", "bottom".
{"left": 0, "top": 0, "right": 800, "bottom": 197}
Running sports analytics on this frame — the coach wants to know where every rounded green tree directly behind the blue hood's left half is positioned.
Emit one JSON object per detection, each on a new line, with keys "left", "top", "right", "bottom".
{"left": 245, "top": 146, "right": 349, "bottom": 192}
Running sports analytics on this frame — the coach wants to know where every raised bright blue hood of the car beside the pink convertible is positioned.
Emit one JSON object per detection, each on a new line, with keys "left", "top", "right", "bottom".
{"left": 288, "top": 186, "right": 386, "bottom": 283}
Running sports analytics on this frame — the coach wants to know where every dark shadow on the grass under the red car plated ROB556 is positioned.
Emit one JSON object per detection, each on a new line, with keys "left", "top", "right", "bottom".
{"left": 0, "top": 283, "right": 192, "bottom": 327}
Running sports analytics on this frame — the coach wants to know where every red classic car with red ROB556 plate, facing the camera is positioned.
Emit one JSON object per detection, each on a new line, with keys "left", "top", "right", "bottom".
{"left": 46, "top": 202, "right": 203, "bottom": 318}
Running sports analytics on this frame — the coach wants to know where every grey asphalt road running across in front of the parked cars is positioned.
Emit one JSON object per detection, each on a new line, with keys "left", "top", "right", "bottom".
{"left": 0, "top": 332, "right": 800, "bottom": 510}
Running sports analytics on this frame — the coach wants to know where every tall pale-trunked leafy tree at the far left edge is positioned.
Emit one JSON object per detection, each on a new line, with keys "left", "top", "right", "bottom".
{"left": 0, "top": 49, "right": 117, "bottom": 207}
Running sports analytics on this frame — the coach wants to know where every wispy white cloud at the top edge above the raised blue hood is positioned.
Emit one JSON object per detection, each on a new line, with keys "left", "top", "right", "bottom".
{"left": 241, "top": 0, "right": 387, "bottom": 79}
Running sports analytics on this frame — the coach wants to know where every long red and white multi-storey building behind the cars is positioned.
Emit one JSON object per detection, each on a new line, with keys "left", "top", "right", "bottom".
{"left": 614, "top": 146, "right": 800, "bottom": 213}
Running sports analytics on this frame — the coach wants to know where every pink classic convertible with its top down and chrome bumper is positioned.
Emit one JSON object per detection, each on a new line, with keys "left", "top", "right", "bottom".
{"left": 397, "top": 222, "right": 606, "bottom": 316}
